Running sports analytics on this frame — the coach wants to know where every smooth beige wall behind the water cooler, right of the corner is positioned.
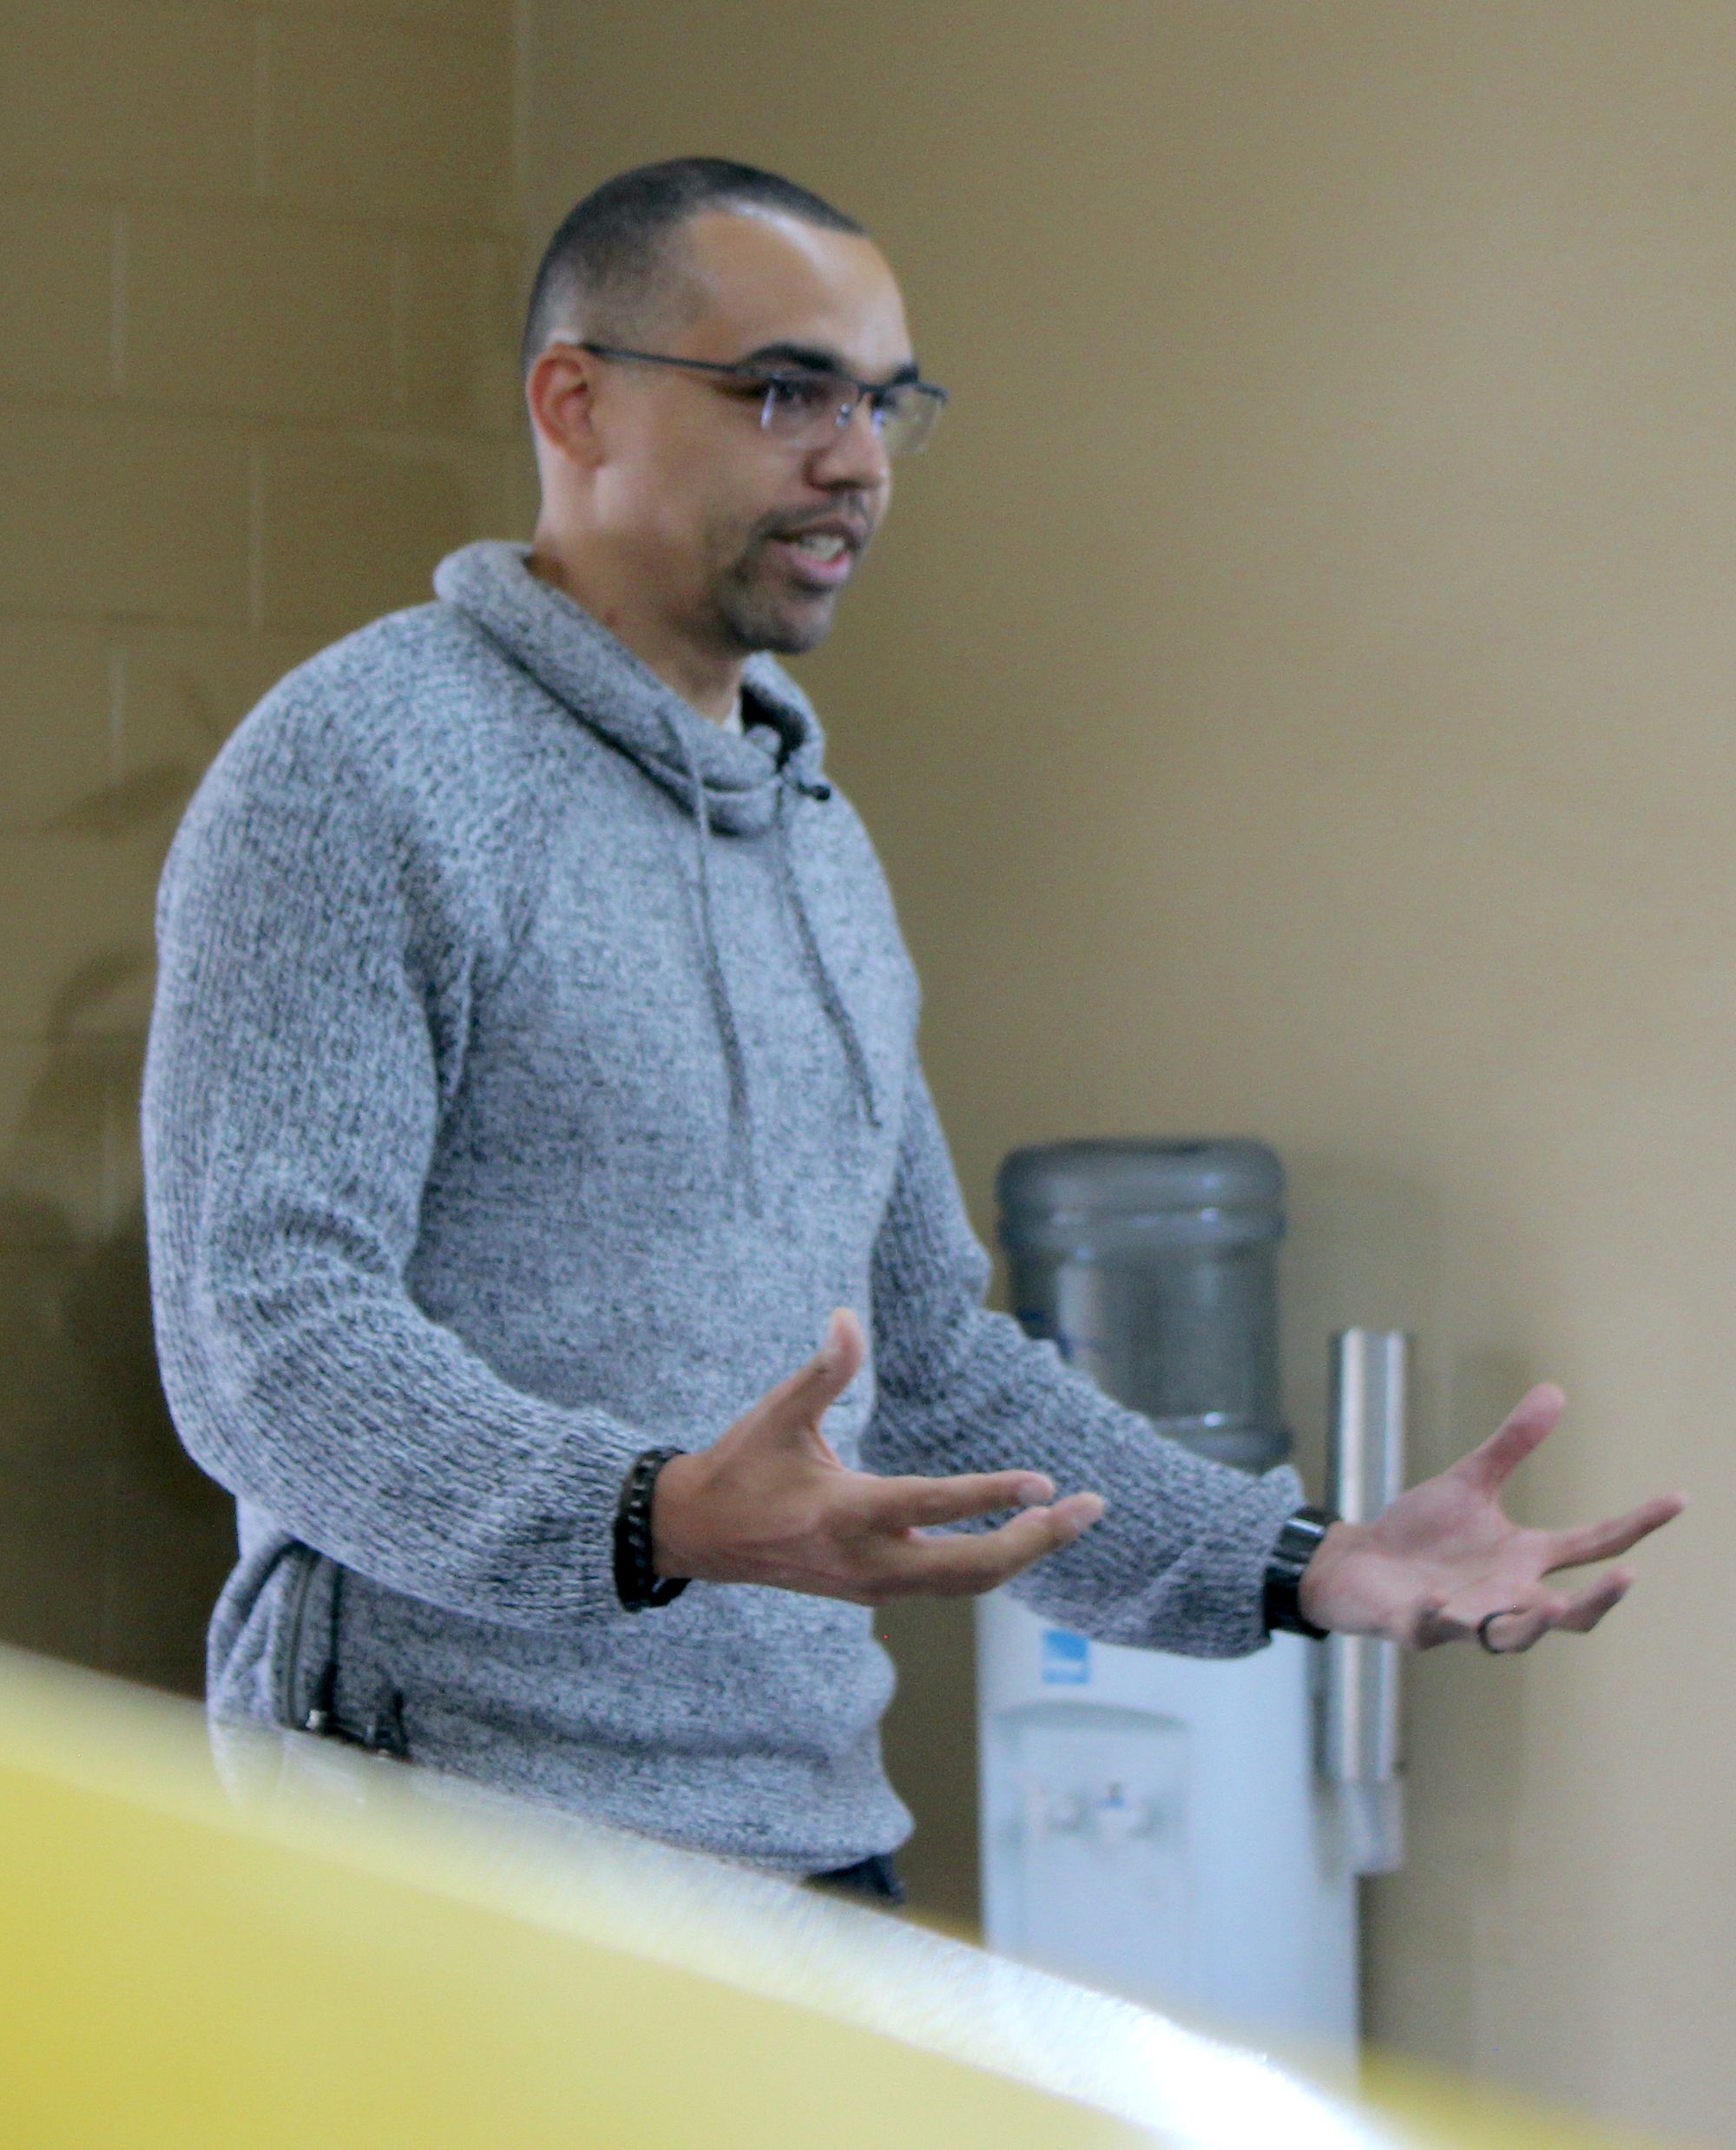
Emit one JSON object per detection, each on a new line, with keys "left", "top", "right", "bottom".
{"left": 527, "top": 0, "right": 1736, "bottom": 2144}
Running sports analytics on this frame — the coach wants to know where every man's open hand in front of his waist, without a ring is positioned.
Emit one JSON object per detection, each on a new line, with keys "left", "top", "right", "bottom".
{"left": 652, "top": 1307, "right": 1103, "bottom": 1606}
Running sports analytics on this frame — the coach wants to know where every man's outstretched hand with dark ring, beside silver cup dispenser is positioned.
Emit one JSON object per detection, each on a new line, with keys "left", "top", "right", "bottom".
{"left": 1301, "top": 1384, "right": 1685, "bottom": 1655}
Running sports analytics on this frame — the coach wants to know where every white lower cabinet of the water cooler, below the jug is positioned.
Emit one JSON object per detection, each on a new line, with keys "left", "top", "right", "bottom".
{"left": 976, "top": 1593, "right": 1358, "bottom": 2049}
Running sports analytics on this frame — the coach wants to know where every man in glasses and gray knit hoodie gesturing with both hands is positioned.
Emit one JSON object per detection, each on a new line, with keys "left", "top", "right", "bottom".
{"left": 144, "top": 159, "right": 1680, "bottom": 1875}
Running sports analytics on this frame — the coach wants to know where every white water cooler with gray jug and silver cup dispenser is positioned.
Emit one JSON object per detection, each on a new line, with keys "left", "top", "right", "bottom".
{"left": 976, "top": 1141, "right": 1404, "bottom": 2049}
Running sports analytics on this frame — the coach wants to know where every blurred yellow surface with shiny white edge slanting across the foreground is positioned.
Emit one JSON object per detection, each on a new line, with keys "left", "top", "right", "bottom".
{"left": 0, "top": 1651, "right": 1694, "bottom": 2150}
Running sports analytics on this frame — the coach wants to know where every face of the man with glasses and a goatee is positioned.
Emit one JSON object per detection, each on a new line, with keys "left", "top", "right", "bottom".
{"left": 594, "top": 213, "right": 912, "bottom": 655}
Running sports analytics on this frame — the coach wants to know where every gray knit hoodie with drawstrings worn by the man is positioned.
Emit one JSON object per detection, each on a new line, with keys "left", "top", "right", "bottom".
{"left": 144, "top": 544, "right": 1299, "bottom": 1871}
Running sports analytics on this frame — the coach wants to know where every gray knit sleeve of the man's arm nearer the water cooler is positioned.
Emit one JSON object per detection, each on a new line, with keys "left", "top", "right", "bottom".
{"left": 863, "top": 1049, "right": 1301, "bottom": 1658}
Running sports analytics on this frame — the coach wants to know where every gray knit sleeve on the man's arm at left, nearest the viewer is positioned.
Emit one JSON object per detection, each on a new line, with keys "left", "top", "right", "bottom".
{"left": 144, "top": 713, "right": 649, "bottom": 1627}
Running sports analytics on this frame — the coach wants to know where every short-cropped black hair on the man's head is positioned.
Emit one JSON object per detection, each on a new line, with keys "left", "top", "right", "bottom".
{"left": 521, "top": 157, "right": 863, "bottom": 372}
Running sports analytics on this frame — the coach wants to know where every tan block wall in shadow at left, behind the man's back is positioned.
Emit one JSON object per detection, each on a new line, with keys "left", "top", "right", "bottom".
{"left": 0, "top": 0, "right": 527, "bottom": 1686}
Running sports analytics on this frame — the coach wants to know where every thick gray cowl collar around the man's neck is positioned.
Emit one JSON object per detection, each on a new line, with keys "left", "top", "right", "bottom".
{"left": 435, "top": 540, "right": 826, "bottom": 837}
